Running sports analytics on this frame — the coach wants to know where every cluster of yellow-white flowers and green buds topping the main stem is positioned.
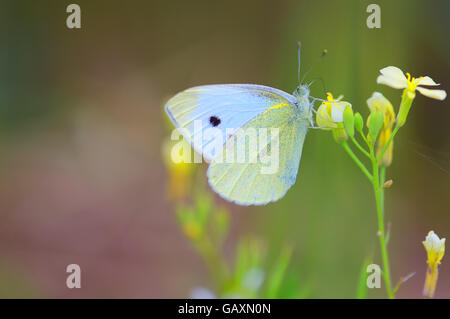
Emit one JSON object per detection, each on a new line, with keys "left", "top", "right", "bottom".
{"left": 316, "top": 66, "right": 447, "bottom": 166}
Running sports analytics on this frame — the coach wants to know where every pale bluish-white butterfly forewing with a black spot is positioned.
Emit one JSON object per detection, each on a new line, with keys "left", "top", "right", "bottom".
{"left": 165, "top": 84, "right": 295, "bottom": 161}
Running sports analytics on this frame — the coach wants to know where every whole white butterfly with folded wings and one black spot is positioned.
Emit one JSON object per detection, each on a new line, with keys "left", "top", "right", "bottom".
{"left": 165, "top": 43, "right": 313, "bottom": 205}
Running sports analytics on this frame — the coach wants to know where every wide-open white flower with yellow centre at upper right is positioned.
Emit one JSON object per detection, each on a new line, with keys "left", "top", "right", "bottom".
{"left": 377, "top": 66, "right": 447, "bottom": 101}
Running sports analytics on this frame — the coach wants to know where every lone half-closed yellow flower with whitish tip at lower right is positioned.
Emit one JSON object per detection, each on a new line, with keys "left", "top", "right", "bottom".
{"left": 422, "top": 231, "right": 445, "bottom": 298}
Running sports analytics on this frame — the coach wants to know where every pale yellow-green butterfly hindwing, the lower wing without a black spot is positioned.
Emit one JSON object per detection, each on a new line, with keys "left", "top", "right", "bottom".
{"left": 207, "top": 106, "right": 309, "bottom": 205}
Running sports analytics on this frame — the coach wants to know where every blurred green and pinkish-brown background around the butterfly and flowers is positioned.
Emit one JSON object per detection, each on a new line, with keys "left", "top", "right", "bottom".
{"left": 0, "top": 0, "right": 450, "bottom": 298}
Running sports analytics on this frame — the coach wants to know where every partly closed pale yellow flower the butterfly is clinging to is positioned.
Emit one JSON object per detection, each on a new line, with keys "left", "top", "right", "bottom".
{"left": 316, "top": 93, "right": 352, "bottom": 129}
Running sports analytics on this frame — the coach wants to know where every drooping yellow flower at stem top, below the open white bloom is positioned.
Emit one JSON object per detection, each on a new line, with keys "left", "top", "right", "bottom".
{"left": 367, "top": 92, "right": 395, "bottom": 166}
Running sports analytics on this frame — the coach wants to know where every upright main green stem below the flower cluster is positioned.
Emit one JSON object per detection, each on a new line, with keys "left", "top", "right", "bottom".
{"left": 371, "top": 153, "right": 394, "bottom": 299}
